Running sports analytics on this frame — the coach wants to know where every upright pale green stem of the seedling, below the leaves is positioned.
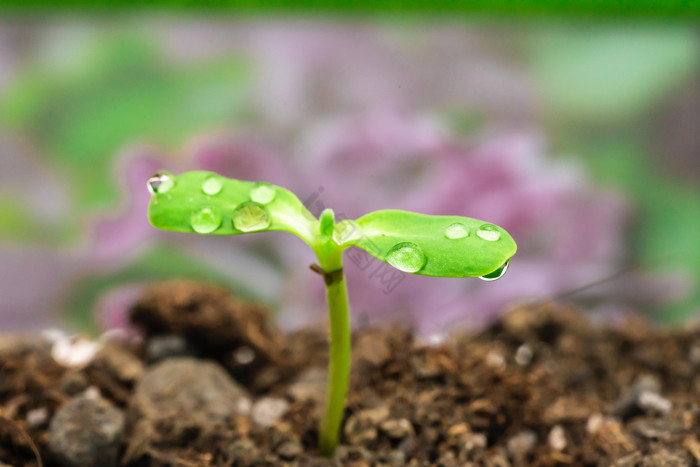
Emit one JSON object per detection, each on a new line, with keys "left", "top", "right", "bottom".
{"left": 319, "top": 248, "right": 350, "bottom": 456}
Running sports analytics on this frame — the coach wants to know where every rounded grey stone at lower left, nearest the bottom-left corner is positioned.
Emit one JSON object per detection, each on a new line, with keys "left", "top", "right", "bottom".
{"left": 49, "top": 395, "right": 124, "bottom": 467}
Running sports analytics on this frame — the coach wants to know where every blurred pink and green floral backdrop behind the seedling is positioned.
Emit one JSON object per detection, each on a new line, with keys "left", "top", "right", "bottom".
{"left": 0, "top": 14, "right": 700, "bottom": 335}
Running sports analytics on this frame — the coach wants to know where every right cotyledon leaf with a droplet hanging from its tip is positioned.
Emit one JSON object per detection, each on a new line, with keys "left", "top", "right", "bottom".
{"left": 334, "top": 210, "right": 517, "bottom": 278}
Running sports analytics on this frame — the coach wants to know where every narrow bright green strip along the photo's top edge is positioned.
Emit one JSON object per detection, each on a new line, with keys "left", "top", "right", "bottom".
{"left": 0, "top": 0, "right": 700, "bottom": 17}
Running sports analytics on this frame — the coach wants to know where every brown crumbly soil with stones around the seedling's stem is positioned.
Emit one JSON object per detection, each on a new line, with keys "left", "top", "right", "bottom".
{"left": 0, "top": 282, "right": 700, "bottom": 467}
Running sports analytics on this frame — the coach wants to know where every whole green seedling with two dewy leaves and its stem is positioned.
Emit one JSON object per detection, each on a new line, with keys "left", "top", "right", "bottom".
{"left": 148, "top": 171, "right": 516, "bottom": 456}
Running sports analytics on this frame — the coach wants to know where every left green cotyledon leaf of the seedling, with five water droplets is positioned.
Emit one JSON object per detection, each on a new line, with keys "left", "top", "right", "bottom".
{"left": 148, "top": 171, "right": 318, "bottom": 242}
